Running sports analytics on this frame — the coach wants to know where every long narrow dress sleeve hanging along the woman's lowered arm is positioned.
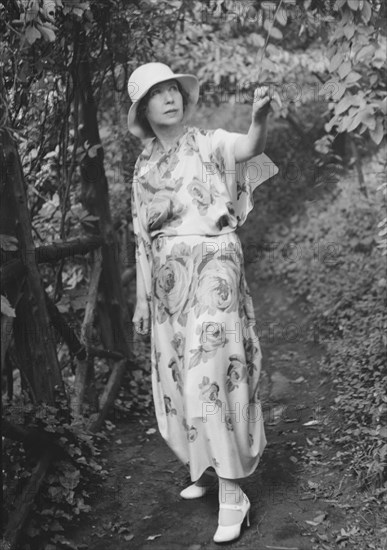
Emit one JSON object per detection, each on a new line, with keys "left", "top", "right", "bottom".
{"left": 131, "top": 160, "right": 152, "bottom": 301}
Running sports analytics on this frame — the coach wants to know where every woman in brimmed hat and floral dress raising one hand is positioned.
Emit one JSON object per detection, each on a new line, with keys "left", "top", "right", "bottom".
{"left": 128, "top": 63, "right": 276, "bottom": 542}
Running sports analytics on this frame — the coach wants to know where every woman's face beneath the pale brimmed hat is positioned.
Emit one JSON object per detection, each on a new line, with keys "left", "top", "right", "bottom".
{"left": 145, "top": 80, "right": 184, "bottom": 127}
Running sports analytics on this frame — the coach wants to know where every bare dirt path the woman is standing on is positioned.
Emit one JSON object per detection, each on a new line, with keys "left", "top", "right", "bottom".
{"left": 68, "top": 263, "right": 350, "bottom": 550}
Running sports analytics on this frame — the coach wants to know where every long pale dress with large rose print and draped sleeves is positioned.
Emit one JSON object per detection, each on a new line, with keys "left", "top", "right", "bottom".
{"left": 132, "top": 127, "right": 277, "bottom": 481}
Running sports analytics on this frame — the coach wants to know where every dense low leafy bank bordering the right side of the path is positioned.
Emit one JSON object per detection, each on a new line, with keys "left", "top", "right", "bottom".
{"left": 265, "top": 153, "right": 387, "bottom": 494}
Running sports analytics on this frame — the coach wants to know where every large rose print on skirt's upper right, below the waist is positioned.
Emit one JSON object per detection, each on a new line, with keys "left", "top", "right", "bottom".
{"left": 194, "top": 258, "right": 240, "bottom": 316}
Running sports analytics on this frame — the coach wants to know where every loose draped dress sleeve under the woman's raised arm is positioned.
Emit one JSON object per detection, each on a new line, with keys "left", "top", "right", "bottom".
{"left": 206, "top": 129, "right": 278, "bottom": 226}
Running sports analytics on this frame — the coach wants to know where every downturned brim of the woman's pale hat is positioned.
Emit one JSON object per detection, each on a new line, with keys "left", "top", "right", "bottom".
{"left": 127, "top": 74, "right": 200, "bottom": 139}
